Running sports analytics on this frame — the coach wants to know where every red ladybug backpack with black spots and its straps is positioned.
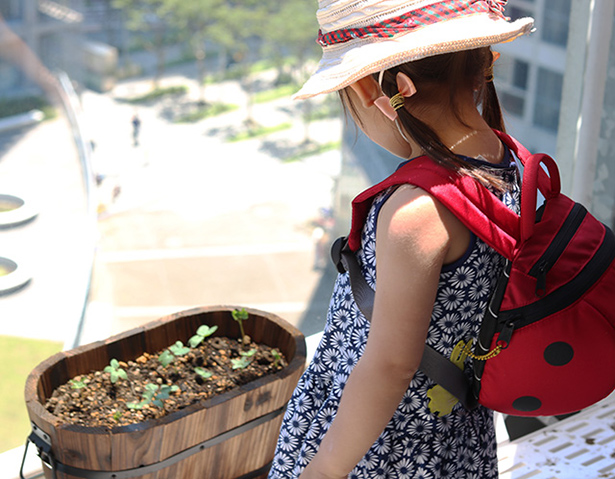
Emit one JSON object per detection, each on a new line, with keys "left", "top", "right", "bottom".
{"left": 332, "top": 132, "right": 615, "bottom": 416}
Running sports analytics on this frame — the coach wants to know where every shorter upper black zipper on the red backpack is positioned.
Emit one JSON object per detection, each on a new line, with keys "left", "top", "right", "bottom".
{"left": 528, "top": 203, "right": 587, "bottom": 297}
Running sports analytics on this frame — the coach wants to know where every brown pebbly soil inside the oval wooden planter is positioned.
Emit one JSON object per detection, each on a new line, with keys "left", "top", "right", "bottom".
{"left": 45, "top": 336, "right": 287, "bottom": 428}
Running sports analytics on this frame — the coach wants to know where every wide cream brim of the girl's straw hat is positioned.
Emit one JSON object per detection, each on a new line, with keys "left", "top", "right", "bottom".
{"left": 293, "top": 13, "right": 534, "bottom": 100}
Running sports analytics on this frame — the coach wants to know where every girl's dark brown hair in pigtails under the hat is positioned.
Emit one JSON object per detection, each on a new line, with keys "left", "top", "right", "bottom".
{"left": 340, "top": 47, "right": 505, "bottom": 187}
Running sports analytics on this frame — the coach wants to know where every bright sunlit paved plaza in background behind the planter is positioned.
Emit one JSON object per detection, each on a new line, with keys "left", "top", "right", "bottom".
{"left": 77, "top": 67, "right": 341, "bottom": 342}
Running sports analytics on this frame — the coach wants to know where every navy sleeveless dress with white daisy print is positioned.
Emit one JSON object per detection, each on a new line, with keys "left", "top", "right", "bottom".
{"left": 269, "top": 153, "right": 520, "bottom": 479}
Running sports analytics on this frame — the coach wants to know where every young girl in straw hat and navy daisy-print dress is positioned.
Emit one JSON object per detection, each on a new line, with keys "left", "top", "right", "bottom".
{"left": 269, "top": 0, "right": 533, "bottom": 479}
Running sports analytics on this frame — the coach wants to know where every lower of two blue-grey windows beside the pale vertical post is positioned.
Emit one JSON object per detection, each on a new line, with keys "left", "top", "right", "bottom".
{"left": 534, "top": 68, "right": 564, "bottom": 132}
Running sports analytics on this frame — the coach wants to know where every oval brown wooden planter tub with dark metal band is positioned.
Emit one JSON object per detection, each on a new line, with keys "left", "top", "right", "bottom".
{"left": 25, "top": 306, "right": 306, "bottom": 479}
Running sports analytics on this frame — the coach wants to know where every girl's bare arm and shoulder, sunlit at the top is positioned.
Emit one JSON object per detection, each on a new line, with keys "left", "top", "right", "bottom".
{"left": 301, "top": 185, "right": 469, "bottom": 479}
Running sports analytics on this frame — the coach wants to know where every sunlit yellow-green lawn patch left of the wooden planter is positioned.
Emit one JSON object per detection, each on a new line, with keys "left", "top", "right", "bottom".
{"left": 0, "top": 336, "right": 62, "bottom": 452}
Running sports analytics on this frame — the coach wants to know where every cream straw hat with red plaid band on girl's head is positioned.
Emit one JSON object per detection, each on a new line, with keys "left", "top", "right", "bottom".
{"left": 293, "top": 0, "right": 534, "bottom": 99}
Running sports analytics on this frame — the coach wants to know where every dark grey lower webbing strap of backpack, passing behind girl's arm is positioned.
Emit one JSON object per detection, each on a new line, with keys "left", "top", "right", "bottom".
{"left": 331, "top": 237, "right": 478, "bottom": 409}
